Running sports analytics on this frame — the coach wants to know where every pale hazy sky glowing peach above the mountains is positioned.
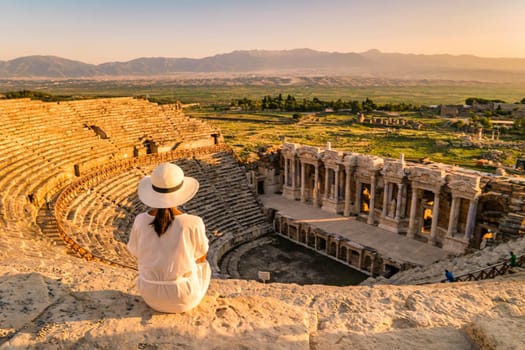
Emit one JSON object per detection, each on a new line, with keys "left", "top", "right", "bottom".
{"left": 0, "top": 0, "right": 525, "bottom": 63}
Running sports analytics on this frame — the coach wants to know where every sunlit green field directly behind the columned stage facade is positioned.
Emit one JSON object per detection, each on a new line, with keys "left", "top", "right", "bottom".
{"left": 190, "top": 111, "right": 520, "bottom": 172}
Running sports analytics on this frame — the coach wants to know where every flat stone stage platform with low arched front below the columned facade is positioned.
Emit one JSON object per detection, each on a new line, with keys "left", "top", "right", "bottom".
{"left": 259, "top": 194, "right": 450, "bottom": 276}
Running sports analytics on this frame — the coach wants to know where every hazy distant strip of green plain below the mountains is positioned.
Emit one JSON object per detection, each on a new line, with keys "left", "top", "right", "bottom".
{"left": 0, "top": 80, "right": 525, "bottom": 106}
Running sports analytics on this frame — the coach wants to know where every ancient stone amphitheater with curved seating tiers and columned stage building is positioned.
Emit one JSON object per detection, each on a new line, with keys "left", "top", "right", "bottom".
{"left": 0, "top": 98, "right": 525, "bottom": 349}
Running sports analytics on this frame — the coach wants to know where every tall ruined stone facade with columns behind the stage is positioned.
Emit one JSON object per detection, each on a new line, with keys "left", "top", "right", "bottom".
{"left": 268, "top": 143, "right": 525, "bottom": 253}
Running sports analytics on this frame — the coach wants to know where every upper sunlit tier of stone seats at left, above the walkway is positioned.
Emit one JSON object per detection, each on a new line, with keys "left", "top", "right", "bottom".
{"left": 0, "top": 98, "right": 222, "bottom": 262}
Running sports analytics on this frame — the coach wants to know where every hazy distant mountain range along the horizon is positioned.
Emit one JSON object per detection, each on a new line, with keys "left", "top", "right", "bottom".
{"left": 0, "top": 49, "right": 525, "bottom": 82}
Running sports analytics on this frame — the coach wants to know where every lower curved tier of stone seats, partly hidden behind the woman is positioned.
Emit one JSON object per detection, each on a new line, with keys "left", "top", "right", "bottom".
{"left": 58, "top": 146, "right": 269, "bottom": 266}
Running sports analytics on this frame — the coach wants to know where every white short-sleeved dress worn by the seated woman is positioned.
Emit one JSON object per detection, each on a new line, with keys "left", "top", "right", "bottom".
{"left": 127, "top": 213, "right": 211, "bottom": 312}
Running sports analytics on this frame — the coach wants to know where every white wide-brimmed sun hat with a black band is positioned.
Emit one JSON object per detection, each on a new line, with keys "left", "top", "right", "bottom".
{"left": 138, "top": 163, "right": 199, "bottom": 208}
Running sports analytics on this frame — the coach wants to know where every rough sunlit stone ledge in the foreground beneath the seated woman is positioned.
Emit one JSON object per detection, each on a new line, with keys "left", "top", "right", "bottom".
{"left": 0, "top": 257, "right": 525, "bottom": 349}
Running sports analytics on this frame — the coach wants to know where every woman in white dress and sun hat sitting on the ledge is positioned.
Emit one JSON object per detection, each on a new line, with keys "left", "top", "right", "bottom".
{"left": 127, "top": 163, "right": 211, "bottom": 312}
